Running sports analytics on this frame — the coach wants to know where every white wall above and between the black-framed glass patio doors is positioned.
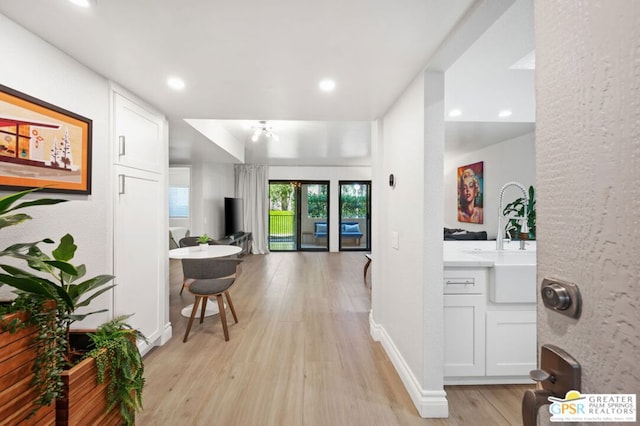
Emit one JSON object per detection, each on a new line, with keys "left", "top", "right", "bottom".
{"left": 269, "top": 166, "right": 375, "bottom": 252}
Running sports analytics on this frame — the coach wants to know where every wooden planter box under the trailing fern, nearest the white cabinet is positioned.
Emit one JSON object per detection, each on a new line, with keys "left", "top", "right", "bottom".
{"left": 56, "top": 330, "right": 123, "bottom": 426}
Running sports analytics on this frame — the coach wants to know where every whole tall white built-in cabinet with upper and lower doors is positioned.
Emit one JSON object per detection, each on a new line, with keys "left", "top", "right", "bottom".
{"left": 110, "top": 85, "right": 171, "bottom": 352}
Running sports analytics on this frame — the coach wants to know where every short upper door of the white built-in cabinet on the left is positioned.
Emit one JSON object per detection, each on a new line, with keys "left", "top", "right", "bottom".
{"left": 113, "top": 92, "right": 167, "bottom": 173}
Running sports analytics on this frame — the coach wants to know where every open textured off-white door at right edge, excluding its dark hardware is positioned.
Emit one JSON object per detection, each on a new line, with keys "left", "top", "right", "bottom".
{"left": 535, "top": 0, "right": 640, "bottom": 420}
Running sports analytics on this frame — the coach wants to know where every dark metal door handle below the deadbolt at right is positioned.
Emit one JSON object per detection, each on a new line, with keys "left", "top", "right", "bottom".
{"left": 522, "top": 345, "right": 581, "bottom": 426}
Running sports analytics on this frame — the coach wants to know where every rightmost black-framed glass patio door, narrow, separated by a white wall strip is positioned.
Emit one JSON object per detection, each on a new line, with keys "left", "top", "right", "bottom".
{"left": 338, "top": 181, "right": 371, "bottom": 251}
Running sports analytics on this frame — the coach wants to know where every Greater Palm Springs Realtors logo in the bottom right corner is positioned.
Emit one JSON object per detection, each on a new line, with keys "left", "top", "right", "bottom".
{"left": 549, "top": 390, "right": 636, "bottom": 422}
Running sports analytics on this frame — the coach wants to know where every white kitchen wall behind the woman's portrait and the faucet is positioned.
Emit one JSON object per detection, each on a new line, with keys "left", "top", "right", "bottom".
{"left": 444, "top": 133, "right": 536, "bottom": 239}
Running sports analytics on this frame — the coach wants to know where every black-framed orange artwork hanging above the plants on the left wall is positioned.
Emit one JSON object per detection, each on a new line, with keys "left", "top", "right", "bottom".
{"left": 0, "top": 85, "right": 92, "bottom": 194}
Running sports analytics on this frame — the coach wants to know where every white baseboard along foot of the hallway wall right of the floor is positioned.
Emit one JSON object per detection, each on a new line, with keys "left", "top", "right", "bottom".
{"left": 369, "top": 311, "right": 449, "bottom": 418}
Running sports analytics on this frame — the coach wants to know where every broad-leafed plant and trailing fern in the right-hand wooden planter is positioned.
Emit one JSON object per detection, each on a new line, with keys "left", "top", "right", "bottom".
{"left": 0, "top": 191, "right": 144, "bottom": 424}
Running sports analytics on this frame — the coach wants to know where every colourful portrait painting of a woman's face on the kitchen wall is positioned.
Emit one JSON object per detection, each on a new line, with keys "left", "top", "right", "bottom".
{"left": 457, "top": 161, "right": 484, "bottom": 223}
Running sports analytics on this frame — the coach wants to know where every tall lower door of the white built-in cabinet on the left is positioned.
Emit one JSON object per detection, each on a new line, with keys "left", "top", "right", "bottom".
{"left": 114, "top": 166, "right": 167, "bottom": 342}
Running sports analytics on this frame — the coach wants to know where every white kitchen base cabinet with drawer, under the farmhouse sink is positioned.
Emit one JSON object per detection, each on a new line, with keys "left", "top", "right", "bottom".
{"left": 443, "top": 267, "right": 536, "bottom": 384}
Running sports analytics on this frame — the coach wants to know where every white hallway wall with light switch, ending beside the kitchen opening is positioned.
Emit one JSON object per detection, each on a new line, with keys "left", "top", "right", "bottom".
{"left": 370, "top": 73, "right": 448, "bottom": 417}
